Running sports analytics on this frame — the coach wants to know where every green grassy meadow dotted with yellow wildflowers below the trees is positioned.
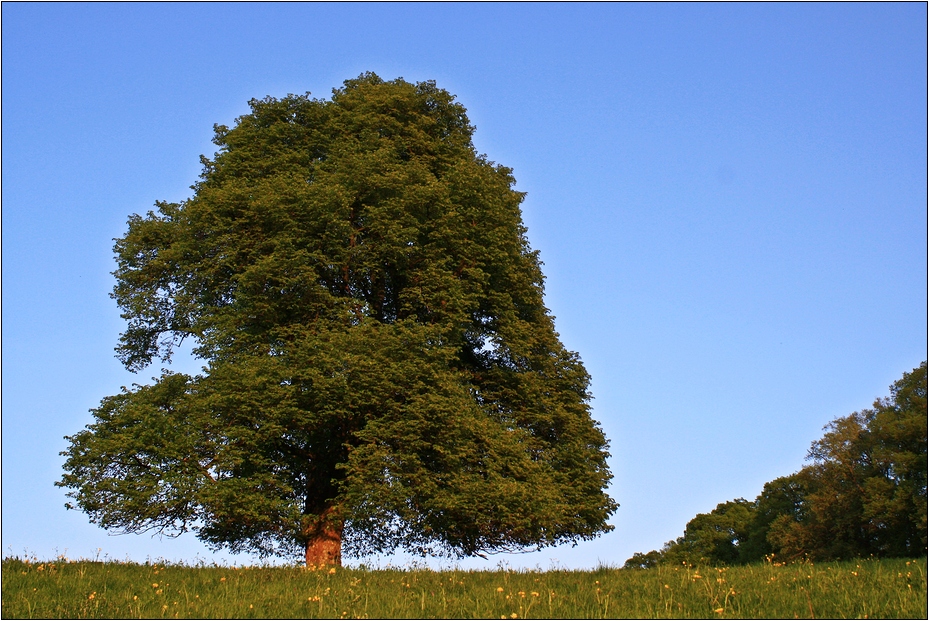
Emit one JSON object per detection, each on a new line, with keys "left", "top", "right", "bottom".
{"left": 2, "top": 558, "right": 927, "bottom": 619}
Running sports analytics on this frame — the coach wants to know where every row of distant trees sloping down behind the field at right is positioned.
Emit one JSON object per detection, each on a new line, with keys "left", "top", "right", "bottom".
{"left": 625, "top": 362, "right": 927, "bottom": 568}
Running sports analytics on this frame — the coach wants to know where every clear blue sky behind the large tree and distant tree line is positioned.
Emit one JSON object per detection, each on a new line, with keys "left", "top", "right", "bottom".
{"left": 2, "top": 2, "right": 927, "bottom": 569}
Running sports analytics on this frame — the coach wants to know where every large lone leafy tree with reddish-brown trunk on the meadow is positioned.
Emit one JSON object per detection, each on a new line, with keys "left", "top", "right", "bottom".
{"left": 58, "top": 74, "right": 617, "bottom": 566}
